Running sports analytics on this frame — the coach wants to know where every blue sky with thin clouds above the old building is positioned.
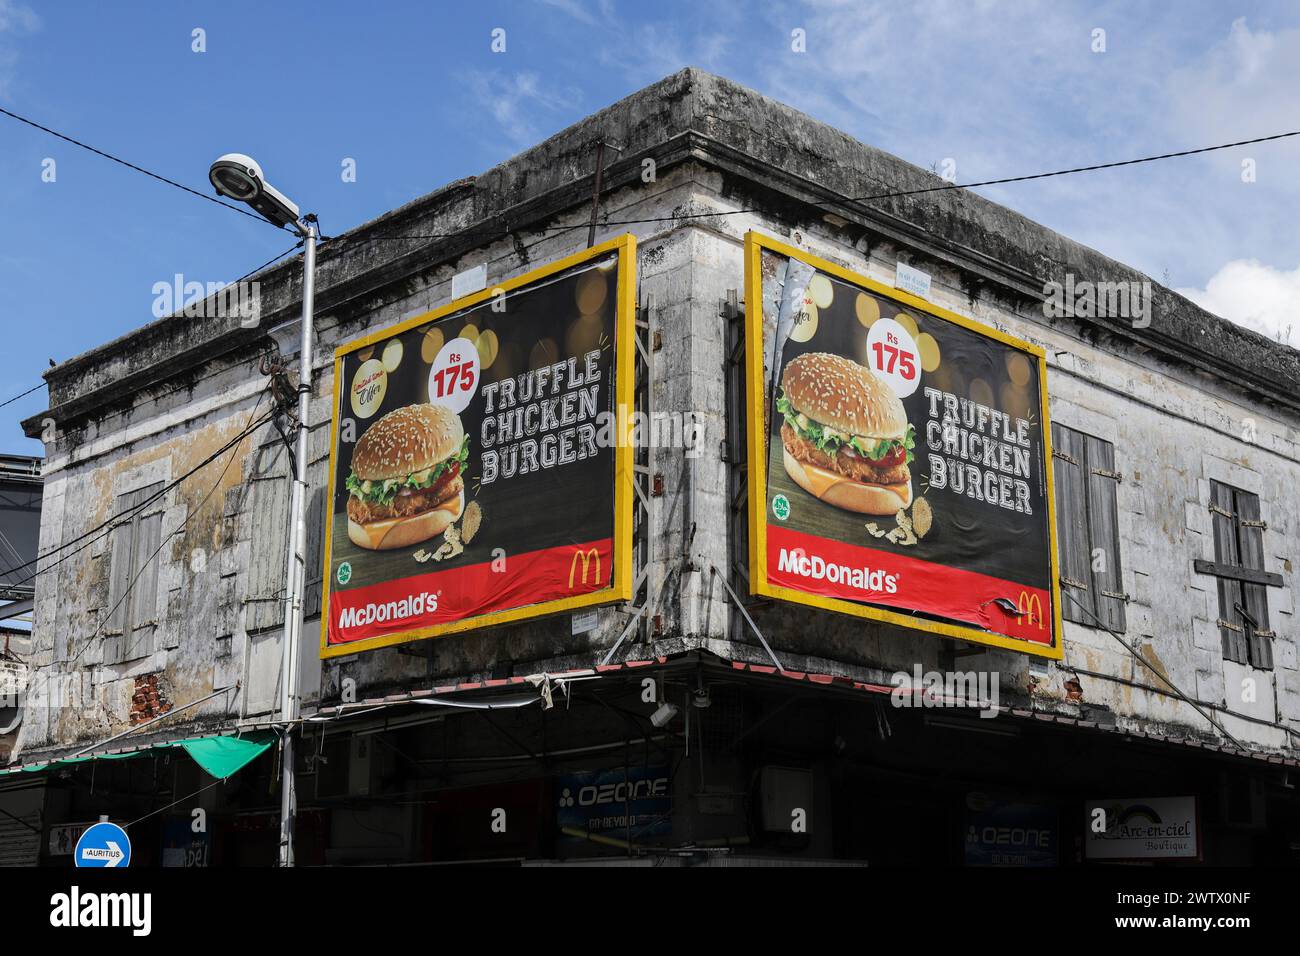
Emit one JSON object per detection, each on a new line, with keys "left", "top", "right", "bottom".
{"left": 0, "top": 0, "right": 1300, "bottom": 454}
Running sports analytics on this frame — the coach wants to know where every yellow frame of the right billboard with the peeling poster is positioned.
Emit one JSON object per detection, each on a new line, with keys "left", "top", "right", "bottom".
{"left": 745, "top": 232, "right": 1065, "bottom": 661}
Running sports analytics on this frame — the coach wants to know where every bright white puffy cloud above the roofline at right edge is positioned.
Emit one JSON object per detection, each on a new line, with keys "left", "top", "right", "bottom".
{"left": 1174, "top": 259, "right": 1300, "bottom": 345}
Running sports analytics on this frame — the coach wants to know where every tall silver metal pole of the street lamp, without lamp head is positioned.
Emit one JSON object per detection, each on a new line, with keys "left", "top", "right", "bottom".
{"left": 280, "top": 217, "right": 316, "bottom": 866}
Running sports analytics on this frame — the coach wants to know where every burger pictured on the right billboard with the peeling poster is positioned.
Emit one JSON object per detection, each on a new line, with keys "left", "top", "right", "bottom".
{"left": 776, "top": 352, "right": 915, "bottom": 515}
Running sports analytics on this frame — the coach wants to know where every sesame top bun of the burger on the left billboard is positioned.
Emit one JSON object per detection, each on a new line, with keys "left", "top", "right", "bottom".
{"left": 352, "top": 405, "right": 465, "bottom": 481}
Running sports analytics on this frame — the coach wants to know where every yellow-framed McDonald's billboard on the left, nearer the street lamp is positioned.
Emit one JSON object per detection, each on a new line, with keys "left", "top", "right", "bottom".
{"left": 321, "top": 235, "right": 636, "bottom": 657}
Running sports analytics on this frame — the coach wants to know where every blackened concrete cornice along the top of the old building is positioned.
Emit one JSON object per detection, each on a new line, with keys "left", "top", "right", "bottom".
{"left": 23, "top": 69, "right": 1300, "bottom": 437}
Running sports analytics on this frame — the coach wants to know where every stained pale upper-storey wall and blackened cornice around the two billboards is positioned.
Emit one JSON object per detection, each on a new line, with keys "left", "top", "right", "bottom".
{"left": 12, "top": 70, "right": 1300, "bottom": 752}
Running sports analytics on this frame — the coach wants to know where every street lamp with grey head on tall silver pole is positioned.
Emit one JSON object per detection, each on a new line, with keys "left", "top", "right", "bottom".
{"left": 208, "top": 152, "right": 316, "bottom": 866}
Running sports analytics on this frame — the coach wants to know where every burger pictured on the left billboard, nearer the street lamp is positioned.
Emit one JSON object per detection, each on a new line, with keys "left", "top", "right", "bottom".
{"left": 346, "top": 405, "right": 469, "bottom": 550}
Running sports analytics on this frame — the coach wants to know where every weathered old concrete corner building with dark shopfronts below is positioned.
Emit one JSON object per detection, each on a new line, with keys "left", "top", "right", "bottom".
{"left": 0, "top": 70, "right": 1300, "bottom": 864}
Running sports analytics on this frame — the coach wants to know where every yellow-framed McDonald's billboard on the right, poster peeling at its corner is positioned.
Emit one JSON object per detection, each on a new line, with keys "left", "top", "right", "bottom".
{"left": 745, "top": 233, "right": 1061, "bottom": 658}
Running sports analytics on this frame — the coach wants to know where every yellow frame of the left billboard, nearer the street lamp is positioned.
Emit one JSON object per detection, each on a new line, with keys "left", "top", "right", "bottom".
{"left": 320, "top": 233, "right": 637, "bottom": 659}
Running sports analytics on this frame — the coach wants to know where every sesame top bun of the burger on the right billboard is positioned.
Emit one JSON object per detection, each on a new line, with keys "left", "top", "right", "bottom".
{"left": 781, "top": 352, "right": 907, "bottom": 442}
